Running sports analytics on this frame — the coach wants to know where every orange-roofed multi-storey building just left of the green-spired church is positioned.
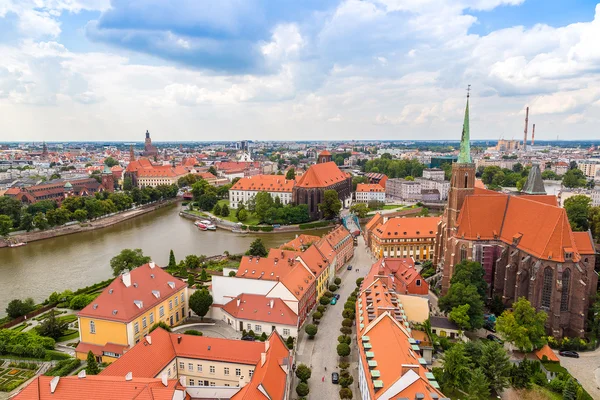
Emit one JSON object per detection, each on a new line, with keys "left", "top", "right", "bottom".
{"left": 367, "top": 213, "right": 440, "bottom": 261}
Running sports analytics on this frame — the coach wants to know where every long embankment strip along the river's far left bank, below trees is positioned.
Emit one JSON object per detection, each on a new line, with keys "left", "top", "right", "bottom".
{"left": 0, "top": 199, "right": 180, "bottom": 248}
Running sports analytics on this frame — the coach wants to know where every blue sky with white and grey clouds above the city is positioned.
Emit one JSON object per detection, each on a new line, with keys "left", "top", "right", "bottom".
{"left": 0, "top": 0, "right": 600, "bottom": 141}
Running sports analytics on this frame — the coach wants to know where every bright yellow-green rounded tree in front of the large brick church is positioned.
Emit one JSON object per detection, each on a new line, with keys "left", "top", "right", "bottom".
{"left": 496, "top": 297, "right": 548, "bottom": 352}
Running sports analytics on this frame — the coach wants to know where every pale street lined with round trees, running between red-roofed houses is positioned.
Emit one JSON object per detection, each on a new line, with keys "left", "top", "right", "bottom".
{"left": 292, "top": 236, "right": 374, "bottom": 399}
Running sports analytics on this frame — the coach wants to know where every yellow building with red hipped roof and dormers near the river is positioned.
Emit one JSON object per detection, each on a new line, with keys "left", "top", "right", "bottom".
{"left": 75, "top": 262, "right": 189, "bottom": 362}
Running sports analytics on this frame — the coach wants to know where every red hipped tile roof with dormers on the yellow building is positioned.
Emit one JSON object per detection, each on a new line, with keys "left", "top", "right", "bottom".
{"left": 79, "top": 263, "right": 187, "bottom": 322}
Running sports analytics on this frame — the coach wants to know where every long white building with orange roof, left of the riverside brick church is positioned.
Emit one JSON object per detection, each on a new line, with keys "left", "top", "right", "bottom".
{"left": 229, "top": 175, "right": 295, "bottom": 208}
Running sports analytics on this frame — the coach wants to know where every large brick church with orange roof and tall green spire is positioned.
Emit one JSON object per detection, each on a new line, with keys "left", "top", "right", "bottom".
{"left": 434, "top": 95, "right": 598, "bottom": 337}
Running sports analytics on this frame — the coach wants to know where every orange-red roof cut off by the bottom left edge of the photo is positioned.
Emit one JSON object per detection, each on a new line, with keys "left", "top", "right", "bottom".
{"left": 13, "top": 374, "right": 185, "bottom": 400}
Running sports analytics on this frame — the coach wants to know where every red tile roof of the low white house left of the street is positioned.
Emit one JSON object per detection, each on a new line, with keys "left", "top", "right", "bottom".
{"left": 222, "top": 294, "right": 298, "bottom": 326}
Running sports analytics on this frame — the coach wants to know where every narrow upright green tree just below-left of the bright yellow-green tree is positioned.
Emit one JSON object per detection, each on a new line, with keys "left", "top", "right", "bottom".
{"left": 473, "top": 341, "right": 511, "bottom": 393}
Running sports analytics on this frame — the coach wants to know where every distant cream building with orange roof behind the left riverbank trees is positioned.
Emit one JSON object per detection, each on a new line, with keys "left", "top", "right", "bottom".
{"left": 124, "top": 158, "right": 188, "bottom": 187}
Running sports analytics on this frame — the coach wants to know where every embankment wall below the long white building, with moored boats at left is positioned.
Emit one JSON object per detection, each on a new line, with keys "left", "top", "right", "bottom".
{"left": 179, "top": 210, "right": 339, "bottom": 234}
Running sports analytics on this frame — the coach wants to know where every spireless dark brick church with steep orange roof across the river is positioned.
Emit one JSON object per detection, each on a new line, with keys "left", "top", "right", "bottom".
{"left": 293, "top": 152, "right": 352, "bottom": 219}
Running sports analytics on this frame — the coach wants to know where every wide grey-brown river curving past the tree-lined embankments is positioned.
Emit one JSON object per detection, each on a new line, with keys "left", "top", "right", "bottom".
{"left": 0, "top": 205, "right": 325, "bottom": 316}
